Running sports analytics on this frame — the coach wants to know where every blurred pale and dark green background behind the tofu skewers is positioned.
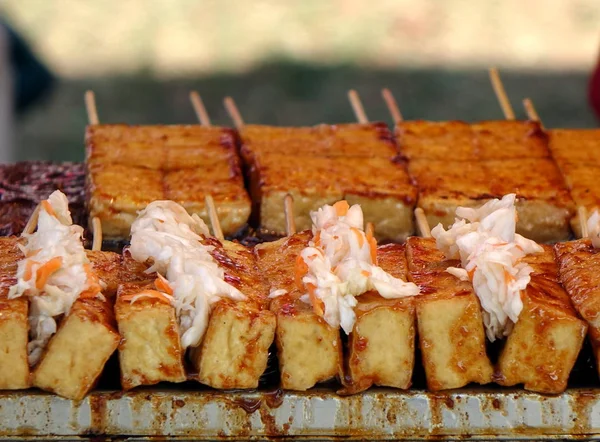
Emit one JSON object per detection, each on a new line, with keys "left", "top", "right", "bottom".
{"left": 0, "top": 0, "right": 600, "bottom": 160}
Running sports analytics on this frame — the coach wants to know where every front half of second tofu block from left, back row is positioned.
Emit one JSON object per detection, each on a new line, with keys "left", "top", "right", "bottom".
{"left": 250, "top": 154, "right": 416, "bottom": 241}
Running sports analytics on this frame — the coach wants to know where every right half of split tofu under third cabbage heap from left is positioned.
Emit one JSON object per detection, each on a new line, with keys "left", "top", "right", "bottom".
{"left": 342, "top": 244, "right": 415, "bottom": 393}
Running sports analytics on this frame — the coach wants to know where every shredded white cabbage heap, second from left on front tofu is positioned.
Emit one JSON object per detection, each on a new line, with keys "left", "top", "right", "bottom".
{"left": 129, "top": 201, "right": 246, "bottom": 349}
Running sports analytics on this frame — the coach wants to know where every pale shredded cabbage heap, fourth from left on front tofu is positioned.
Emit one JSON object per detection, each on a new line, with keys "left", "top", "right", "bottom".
{"left": 431, "top": 194, "right": 544, "bottom": 342}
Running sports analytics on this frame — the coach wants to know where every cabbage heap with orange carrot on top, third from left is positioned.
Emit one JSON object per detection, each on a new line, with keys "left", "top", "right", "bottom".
{"left": 296, "top": 201, "right": 419, "bottom": 334}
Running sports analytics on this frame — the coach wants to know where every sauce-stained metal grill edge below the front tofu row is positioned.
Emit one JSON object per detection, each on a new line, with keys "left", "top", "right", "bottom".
{"left": 0, "top": 389, "right": 600, "bottom": 440}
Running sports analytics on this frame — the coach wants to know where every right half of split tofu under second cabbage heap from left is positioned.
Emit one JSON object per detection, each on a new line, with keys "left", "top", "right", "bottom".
{"left": 190, "top": 239, "right": 276, "bottom": 389}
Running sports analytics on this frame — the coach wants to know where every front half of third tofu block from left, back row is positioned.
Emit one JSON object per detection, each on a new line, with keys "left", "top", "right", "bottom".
{"left": 409, "top": 158, "right": 574, "bottom": 242}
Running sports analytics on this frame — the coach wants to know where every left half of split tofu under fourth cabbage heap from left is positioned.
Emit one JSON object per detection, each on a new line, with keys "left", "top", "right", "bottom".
{"left": 406, "top": 237, "right": 493, "bottom": 391}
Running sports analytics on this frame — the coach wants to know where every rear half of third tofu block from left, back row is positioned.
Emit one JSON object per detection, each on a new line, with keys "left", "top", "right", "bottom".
{"left": 396, "top": 120, "right": 550, "bottom": 161}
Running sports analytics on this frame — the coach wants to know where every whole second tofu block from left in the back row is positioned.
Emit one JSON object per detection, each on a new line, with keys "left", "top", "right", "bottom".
{"left": 240, "top": 123, "right": 416, "bottom": 241}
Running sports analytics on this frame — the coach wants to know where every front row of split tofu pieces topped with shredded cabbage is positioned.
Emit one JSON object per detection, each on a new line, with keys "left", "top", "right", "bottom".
{"left": 0, "top": 191, "right": 600, "bottom": 399}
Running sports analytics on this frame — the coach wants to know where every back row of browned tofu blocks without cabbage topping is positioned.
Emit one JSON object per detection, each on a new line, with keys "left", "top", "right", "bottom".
{"left": 86, "top": 121, "right": 600, "bottom": 242}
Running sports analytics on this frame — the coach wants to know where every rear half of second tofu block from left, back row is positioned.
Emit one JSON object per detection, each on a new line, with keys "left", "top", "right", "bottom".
{"left": 240, "top": 123, "right": 397, "bottom": 162}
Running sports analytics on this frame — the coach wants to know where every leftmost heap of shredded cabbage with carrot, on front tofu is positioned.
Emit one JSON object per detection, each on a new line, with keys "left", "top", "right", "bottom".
{"left": 8, "top": 190, "right": 102, "bottom": 366}
